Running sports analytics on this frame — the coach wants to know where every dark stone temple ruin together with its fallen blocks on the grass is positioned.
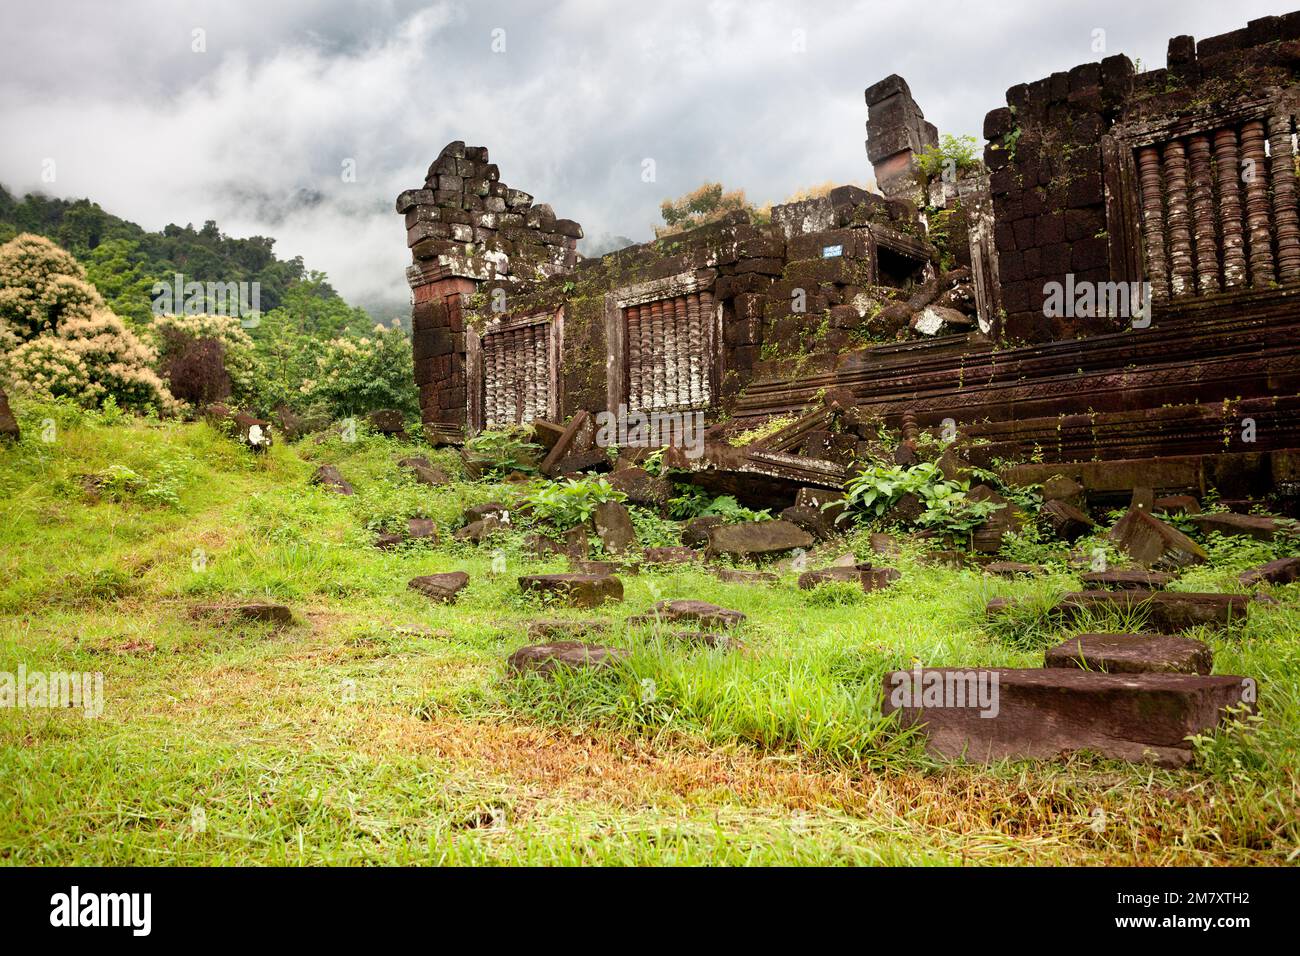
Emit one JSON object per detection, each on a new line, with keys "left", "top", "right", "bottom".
{"left": 384, "top": 12, "right": 1300, "bottom": 765}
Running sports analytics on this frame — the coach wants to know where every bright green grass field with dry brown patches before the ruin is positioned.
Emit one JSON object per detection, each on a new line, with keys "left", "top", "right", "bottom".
{"left": 0, "top": 408, "right": 1300, "bottom": 865}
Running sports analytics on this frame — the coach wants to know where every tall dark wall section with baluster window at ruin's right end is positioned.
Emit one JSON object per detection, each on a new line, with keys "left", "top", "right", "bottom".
{"left": 984, "top": 13, "right": 1300, "bottom": 342}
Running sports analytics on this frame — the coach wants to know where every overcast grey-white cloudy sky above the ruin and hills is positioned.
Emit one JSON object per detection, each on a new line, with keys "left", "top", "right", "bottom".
{"left": 0, "top": 0, "right": 1300, "bottom": 310}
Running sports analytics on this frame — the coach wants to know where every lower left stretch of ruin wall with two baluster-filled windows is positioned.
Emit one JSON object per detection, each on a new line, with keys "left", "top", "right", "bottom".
{"left": 398, "top": 143, "right": 976, "bottom": 441}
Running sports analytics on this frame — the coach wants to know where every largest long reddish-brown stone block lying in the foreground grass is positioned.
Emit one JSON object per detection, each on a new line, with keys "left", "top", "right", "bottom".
{"left": 883, "top": 667, "right": 1253, "bottom": 766}
